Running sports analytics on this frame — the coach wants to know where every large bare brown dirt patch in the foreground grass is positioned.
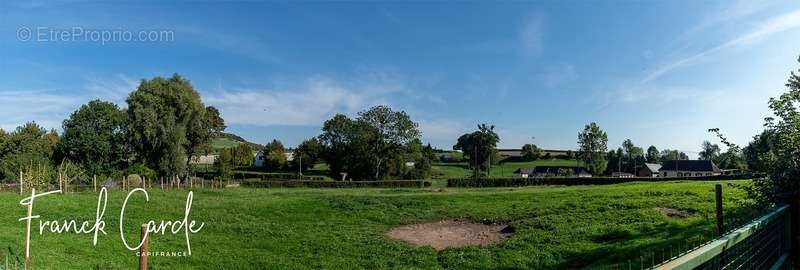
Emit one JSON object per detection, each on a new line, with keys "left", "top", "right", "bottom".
{"left": 386, "top": 220, "right": 514, "bottom": 250}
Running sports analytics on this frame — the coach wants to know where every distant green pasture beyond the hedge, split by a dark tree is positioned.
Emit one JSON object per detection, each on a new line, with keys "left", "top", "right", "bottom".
{"left": 431, "top": 159, "right": 578, "bottom": 179}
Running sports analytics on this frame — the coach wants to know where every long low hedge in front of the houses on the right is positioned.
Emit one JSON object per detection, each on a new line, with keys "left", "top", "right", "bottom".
{"left": 447, "top": 174, "right": 760, "bottom": 187}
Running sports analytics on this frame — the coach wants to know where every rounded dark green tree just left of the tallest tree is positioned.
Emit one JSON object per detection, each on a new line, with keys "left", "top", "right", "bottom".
{"left": 55, "top": 100, "right": 131, "bottom": 175}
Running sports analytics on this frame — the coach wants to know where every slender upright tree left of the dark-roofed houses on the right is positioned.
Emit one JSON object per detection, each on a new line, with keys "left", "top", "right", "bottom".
{"left": 578, "top": 122, "right": 608, "bottom": 175}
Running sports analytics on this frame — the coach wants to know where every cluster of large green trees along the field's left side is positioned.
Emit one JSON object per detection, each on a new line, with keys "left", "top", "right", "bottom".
{"left": 0, "top": 74, "right": 225, "bottom": 187}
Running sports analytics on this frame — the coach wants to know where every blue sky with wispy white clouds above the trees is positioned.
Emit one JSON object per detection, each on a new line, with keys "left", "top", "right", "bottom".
{"left": 0, "top": 1, "right": 800, "bottom": 156}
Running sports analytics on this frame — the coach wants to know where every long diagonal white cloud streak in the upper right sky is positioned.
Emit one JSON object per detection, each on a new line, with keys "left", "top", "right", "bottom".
{"left": 642, "top": 10, "right": 800, "bottom": 83}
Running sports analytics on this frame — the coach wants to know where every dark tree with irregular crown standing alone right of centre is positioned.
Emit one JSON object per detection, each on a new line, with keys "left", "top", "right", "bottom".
{"left": 453, "top": 124, "right": 500, "bottom": 176}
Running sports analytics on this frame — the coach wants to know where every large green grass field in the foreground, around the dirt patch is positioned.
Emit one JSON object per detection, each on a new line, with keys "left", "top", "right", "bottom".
{"left": 0, "top": 181, "right": 747, "bottom": 269}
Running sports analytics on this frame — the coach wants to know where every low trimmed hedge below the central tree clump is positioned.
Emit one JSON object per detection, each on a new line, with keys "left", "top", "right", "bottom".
{"left": 241, "top": 180, "right": 431, "bottom": 188}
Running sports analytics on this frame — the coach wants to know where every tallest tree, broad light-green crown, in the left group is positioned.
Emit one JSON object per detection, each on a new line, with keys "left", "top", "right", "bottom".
{"left": 127, "top": 74, "right": 208, "bottom": 175}
